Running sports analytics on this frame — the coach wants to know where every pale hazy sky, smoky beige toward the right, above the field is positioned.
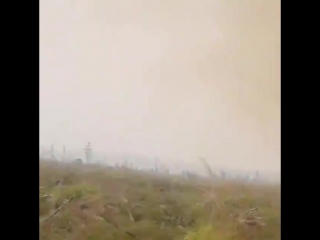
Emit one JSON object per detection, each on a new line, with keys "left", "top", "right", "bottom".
{"left": 40, "top": 0, "right": 280, "bottom": 170}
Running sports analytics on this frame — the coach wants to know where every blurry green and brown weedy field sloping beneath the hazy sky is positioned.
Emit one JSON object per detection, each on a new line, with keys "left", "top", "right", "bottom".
{"left": 39, "top": 162, "right": 281, "bottom": 240}
